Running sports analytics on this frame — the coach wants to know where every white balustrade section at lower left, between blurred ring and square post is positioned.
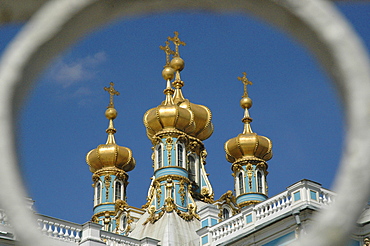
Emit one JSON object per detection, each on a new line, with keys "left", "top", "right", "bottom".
{"left": 37, "top": 215, "right": 82, "bottom": 244}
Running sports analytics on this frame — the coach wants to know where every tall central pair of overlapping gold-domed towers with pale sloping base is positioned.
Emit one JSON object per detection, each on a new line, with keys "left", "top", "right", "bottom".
{"left": 131, "top": 32, "right": 213, "bottom": 245}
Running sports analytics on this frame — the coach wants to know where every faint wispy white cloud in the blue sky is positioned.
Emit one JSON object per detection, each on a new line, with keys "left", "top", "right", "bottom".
{"left": 50, "top": 51, "right": 106, "bottom": 88}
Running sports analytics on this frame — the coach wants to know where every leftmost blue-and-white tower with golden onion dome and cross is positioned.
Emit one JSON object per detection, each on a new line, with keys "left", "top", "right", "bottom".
{"left": 86, "top": 83, "right": 135, "bottom": 232}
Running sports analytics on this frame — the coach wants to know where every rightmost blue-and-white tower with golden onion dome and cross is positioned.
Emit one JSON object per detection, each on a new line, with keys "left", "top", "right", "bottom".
{"left": 225, "top": 73, "right": 272, "bottom": 208}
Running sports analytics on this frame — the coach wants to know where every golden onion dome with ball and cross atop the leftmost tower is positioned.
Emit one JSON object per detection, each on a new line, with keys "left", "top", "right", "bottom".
{"left": 86, "top": 83, "right": 136, "bottom": 173}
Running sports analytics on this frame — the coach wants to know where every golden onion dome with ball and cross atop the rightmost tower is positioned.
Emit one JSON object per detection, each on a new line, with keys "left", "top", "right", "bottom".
{"left": 225, "top": 73, "right": 272, "bottom": 163}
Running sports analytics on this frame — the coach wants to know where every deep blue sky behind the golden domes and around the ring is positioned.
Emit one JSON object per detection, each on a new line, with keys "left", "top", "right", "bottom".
{"left": 0, "top": 3, "right": 370, "bottom": 223}
